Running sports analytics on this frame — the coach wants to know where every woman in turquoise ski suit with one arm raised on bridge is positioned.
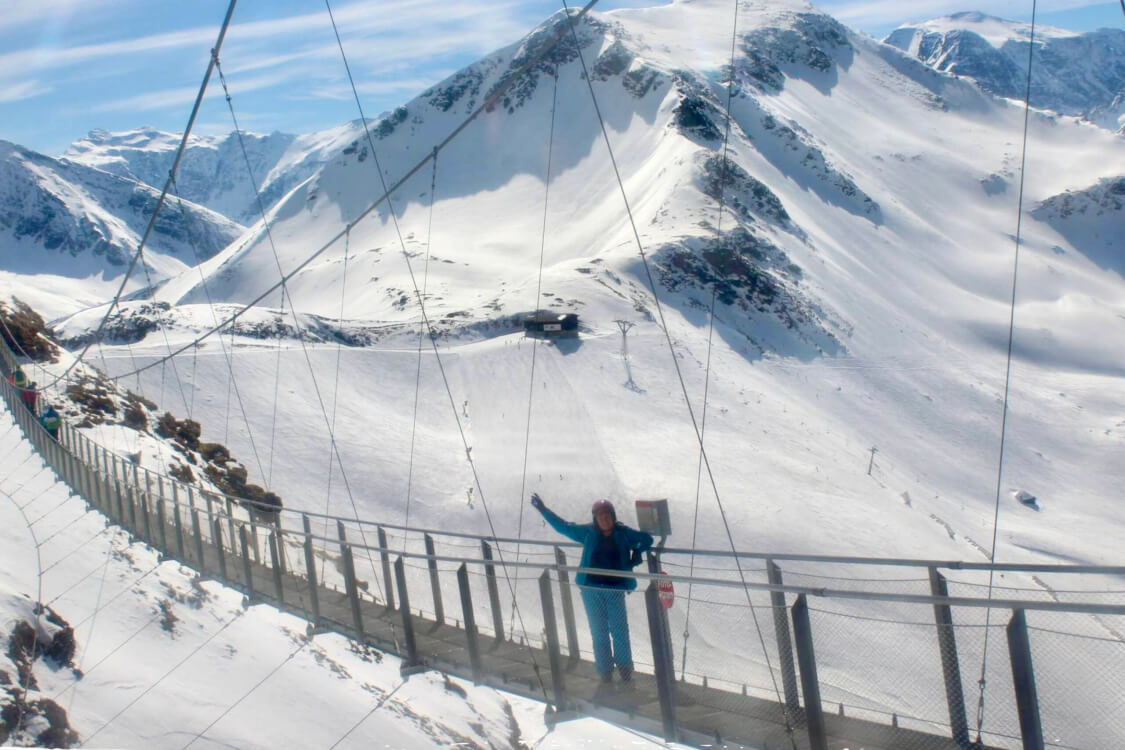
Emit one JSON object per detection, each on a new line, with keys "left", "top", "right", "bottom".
{"left": 531, "top": 494, "right": 653, "bottom": 684}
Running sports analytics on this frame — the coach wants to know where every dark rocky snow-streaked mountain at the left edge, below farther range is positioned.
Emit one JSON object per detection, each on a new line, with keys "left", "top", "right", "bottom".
{"left": 0, "top": 142, "right": 245, "bottom": 281}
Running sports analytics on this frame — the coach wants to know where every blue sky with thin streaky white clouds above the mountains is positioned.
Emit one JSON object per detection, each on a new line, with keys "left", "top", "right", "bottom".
{"left": 0, "top": 0, "right": 1125, "bottom": 155}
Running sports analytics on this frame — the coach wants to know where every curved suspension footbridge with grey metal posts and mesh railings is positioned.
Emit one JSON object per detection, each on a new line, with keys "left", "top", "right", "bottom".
{"left": 0, "top": 346, "right": 1125, "bottom": 750}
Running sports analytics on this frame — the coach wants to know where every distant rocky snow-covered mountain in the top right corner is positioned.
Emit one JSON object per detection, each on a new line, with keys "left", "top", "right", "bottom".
{"left": 884, "top": 11, "right": 1125, "bottom": 130}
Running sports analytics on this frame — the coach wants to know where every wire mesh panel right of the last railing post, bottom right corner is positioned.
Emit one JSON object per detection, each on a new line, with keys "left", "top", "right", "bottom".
{"left": 1027, "top": 612, "right": 1125, "bottom": 750}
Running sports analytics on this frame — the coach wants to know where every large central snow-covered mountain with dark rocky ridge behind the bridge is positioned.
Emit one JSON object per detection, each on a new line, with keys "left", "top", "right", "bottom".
{"left": 39, "top": 2, "right": 1125, "bottom": 571}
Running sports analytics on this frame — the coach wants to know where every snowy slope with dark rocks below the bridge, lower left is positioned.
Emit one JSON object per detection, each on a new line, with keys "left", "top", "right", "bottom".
{"left": 0, "top": 402, "right": 661, "bottom": 748}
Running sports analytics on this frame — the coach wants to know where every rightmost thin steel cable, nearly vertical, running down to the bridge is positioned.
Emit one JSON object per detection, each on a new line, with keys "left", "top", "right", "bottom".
{"left": 977, "top": 0, "right": 1039, "bottom": 744}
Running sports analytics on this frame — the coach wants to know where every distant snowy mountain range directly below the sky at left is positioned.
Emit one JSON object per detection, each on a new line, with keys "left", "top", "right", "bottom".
{"left": 63, "top": 128, "right": 351, "bottom": 224}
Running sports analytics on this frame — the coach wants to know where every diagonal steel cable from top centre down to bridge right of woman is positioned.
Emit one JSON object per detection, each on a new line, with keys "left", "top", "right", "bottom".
{"left": 563, "top": 0, "right": 797, "bottom": 737}
